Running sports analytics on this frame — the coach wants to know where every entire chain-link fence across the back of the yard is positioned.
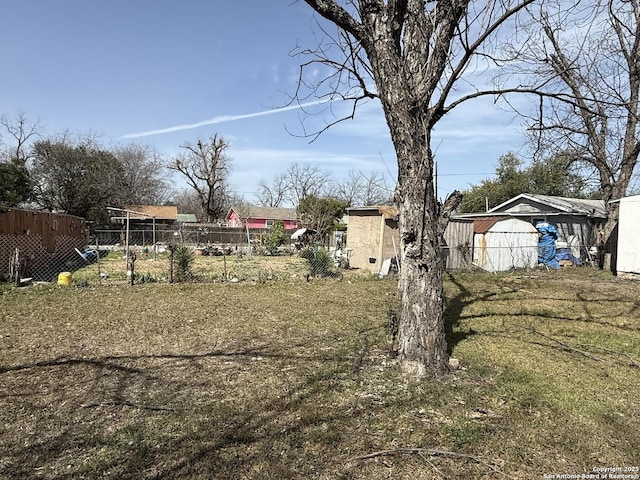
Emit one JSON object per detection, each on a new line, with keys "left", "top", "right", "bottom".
{"left": 0, "top": 228, "right": 598, "bottom": 285}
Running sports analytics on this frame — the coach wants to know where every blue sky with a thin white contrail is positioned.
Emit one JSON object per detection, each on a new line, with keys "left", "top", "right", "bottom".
{"left": 0, "top": 0, "right": 523, "bottom": 200}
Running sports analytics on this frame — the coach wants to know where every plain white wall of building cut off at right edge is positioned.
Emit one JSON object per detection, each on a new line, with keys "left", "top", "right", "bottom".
{"left": 616, "top": 195, "right": 640, "bottom": 275}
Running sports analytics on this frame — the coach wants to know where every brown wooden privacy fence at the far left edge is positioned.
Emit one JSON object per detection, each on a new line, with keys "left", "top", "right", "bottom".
{"left": 0, "top": 209, "right": 88, "bottom": 281}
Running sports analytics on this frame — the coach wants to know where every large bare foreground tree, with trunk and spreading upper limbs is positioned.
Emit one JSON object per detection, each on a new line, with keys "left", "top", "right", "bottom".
{"left": 298, "top": 0, "right": 533, "bottom": 377}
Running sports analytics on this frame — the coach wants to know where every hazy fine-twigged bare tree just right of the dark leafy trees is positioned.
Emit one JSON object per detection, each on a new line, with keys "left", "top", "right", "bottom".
{"left": 113, "top": 144, "right": 169, "bottom": 205}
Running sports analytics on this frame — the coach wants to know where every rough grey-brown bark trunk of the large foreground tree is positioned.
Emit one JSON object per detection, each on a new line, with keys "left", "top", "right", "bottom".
{"left": 356, "top": 2, "right": 456, "bottom": 378}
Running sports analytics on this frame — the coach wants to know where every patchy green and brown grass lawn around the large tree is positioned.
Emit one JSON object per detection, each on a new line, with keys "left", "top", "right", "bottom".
{"left": 0, "top": 268, "right": 640, "bottom": 479}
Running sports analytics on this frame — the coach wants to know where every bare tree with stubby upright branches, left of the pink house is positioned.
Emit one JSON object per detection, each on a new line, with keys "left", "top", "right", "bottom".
{"left": 168, "top": 135, "right": 231, "bottom": 222}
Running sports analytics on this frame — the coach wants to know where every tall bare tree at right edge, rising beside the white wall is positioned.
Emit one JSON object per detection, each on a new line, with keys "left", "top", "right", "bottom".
{"left": 501, "top": 0, "right": 640, "bottom": 248}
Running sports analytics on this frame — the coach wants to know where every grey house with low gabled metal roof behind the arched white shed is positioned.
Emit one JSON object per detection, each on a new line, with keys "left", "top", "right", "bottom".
{"left": 460, "top": 193, "right": 606, "bottom": 259}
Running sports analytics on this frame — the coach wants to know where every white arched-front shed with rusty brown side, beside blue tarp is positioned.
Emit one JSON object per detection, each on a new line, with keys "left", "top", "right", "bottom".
{"left": 473, "top": 217, "right": 538, "bottom": 272}
